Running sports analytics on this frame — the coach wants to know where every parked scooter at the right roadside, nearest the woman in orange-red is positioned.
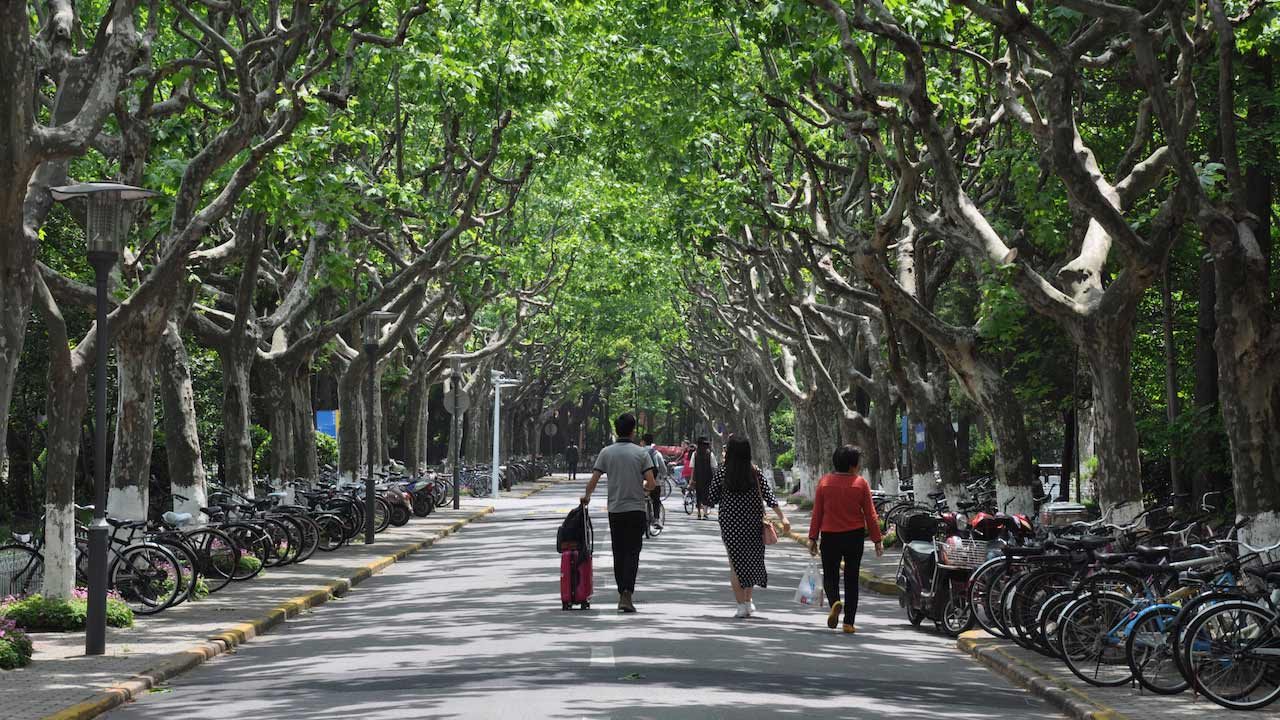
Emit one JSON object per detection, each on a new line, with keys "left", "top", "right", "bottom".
{"left": 897, "top": 512, "right": 987, "bottom": 637}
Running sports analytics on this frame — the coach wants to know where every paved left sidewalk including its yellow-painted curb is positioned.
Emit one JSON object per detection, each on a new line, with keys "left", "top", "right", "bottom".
{"left": 0, "top": 482, "right": 553, "bottom": 720}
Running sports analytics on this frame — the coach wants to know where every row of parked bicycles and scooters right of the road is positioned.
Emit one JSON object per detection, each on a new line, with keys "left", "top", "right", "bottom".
{"left": 886, "top": 484, "right": 1280, "bottom": 710}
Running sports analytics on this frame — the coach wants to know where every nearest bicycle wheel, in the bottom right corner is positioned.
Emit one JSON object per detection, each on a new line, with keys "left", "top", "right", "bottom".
{"left": 1183, "top": 600, "right": 1280, "bottom": 710}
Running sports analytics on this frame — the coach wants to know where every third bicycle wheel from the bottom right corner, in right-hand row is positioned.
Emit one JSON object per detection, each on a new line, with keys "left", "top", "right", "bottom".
{"left": 1059, "top": 592, "right": 1133, "bottom": 687}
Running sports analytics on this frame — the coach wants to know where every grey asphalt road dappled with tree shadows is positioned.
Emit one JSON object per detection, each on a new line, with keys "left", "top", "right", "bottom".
{"left": 110, "top": 476, "right": 1059, "bottom": 720}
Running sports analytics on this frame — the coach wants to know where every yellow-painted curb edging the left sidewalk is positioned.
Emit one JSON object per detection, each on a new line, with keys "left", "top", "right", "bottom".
{"left": 44, "top": 504, "right": 494, "bottom": 720}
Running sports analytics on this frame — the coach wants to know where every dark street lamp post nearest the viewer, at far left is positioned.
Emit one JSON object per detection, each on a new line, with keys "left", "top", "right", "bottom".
{"left": 49, "top": 182, "right": 160, "bottom": 655}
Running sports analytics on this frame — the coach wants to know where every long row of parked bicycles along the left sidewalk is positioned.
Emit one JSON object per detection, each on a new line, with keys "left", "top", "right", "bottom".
{"left": 0, "top": 464, "right": 545, "bottom": 615}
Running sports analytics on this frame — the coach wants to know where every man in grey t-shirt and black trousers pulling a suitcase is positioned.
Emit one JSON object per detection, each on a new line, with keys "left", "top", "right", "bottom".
{"left": 582, "top": 413, "right": 657, "bottom": 612}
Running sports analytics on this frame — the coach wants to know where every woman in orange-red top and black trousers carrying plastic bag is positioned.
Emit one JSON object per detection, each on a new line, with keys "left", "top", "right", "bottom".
{"left": 809, "top": 445, "right": 884, "bottom": 633}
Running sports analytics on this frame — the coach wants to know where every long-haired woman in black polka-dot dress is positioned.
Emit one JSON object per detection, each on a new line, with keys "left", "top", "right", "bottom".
{"left": 707, "top": 438, "right": 791, "bottom": 618}
